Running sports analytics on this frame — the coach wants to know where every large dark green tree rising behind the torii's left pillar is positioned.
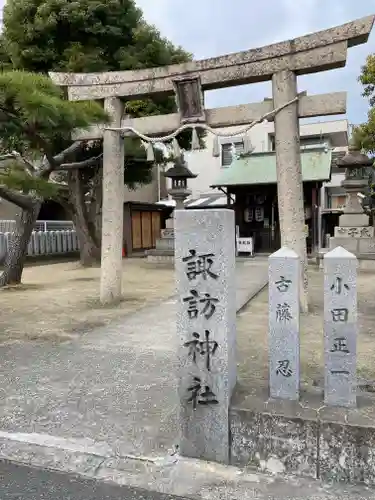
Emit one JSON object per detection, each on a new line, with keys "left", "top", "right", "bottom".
{"left": 0, "top": 0, "right": 197, "bottom": 265}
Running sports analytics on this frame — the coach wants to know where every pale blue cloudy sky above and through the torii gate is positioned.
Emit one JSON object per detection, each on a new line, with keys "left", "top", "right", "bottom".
{"left": 136, "top": 0, "right": 375, "bottom": 123}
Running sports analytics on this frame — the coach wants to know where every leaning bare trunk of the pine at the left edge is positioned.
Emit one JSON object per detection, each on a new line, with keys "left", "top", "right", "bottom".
{"left": 0, "top": 201, "right": 41, "bottom": 287}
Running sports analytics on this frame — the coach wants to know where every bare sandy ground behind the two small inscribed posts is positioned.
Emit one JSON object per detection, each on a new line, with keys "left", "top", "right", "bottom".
{"left": 237, "top": 267, "right": 375, "bottom": 391}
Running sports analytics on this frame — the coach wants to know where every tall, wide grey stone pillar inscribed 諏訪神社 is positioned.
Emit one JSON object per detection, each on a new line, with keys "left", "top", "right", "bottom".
{"left": 175, "top": 209, "right": 236, "bottom": 463}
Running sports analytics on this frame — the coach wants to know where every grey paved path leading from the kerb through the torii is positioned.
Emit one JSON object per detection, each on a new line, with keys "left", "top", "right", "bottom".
{"left": 0, "top": 259, "right": 267, "bottom": 470}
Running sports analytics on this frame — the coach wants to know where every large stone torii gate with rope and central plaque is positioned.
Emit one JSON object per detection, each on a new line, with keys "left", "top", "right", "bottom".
{"left": 50, "top": 16, "right": 375, "bottom": 304}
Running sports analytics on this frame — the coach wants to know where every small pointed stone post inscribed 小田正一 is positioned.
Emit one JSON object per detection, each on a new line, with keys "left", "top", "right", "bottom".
{"left": 324, "top": 247, "right": 358, "bottom": 407}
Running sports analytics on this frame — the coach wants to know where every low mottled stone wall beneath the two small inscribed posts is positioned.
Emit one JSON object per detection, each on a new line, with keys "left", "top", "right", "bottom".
{"left": 230, "top": 385, "right": 375, "bottom": 486}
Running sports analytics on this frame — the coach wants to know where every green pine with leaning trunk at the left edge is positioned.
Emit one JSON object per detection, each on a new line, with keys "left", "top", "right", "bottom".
{"left": 0, "top": 71, "right": 109, "bottom": 286}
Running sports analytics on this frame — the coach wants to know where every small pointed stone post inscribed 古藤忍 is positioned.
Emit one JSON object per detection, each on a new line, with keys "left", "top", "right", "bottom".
{"left": 268, "top": 247, "right": 301, "bottom": 400}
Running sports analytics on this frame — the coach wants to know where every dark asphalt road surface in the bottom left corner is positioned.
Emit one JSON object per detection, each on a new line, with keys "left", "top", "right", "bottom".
{"left": 0, "top": 461, "right": 189, "bottom": 500}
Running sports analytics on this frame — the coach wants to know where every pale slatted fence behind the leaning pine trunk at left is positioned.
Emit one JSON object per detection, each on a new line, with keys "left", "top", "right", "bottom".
{"left": 0, "top": 230, "right": 79, "bottom": 257}
